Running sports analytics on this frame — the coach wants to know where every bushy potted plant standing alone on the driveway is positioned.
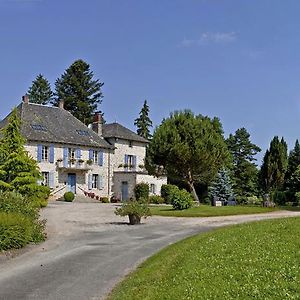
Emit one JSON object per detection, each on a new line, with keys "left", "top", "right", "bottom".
{"left": 115, "top": 200, "right": 151, "bottom": 225}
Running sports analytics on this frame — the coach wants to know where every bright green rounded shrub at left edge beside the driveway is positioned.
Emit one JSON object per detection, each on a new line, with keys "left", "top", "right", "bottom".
{"left": 0, "top": 212, "right": 33, "bottom": 250}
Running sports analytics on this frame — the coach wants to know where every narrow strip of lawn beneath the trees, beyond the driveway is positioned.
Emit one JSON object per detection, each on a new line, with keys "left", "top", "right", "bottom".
{"left": 150, "top": 205, "right": 279, "bottom": 217}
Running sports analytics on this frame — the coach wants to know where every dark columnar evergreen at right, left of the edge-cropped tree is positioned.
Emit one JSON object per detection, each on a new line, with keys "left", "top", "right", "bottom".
{"left": 259, "top": 136, "right": 288, "bottom": 192}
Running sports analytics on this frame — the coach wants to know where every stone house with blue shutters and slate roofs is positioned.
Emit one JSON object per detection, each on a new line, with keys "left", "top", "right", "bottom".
{"left": 0, "top": 96, "right": 167, "bottom": 200}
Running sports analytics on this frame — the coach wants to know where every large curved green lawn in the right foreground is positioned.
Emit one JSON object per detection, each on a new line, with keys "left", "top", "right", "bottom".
{"left": 109, "top": 218, "right": 300, "bottom": 300}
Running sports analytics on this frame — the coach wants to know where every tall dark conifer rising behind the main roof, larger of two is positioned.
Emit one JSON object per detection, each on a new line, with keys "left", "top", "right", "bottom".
{"left": 52, "top": 59, "right": 103, "bottom": 125}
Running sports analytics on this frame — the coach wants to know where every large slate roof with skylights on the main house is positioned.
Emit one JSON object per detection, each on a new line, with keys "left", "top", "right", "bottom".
{"left": 0, "top": 103, "right": 112, "bottom": 149}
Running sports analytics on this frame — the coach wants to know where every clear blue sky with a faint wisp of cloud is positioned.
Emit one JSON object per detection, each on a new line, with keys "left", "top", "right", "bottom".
{"left": 0, "top": 0, "right": 300, "bottom": 164}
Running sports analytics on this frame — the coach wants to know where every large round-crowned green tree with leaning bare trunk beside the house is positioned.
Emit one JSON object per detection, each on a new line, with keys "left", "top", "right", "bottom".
{"left": 147, "top": 110, "right": 229, "bottom": 201}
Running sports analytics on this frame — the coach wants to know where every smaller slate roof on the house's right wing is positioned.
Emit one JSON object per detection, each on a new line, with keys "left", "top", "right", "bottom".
{"left": 102, "top": 123, "right": 149, "bottom": 143}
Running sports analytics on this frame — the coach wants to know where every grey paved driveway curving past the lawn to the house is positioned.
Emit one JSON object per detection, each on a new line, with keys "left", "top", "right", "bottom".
{"left": 0, "top": 202, "right": 300, "bottom": 300}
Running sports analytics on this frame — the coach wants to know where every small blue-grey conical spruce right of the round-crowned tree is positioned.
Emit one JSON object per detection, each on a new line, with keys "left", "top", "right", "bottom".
{"left": 209, "top": 168, "right": 234, "bottom": 200}
